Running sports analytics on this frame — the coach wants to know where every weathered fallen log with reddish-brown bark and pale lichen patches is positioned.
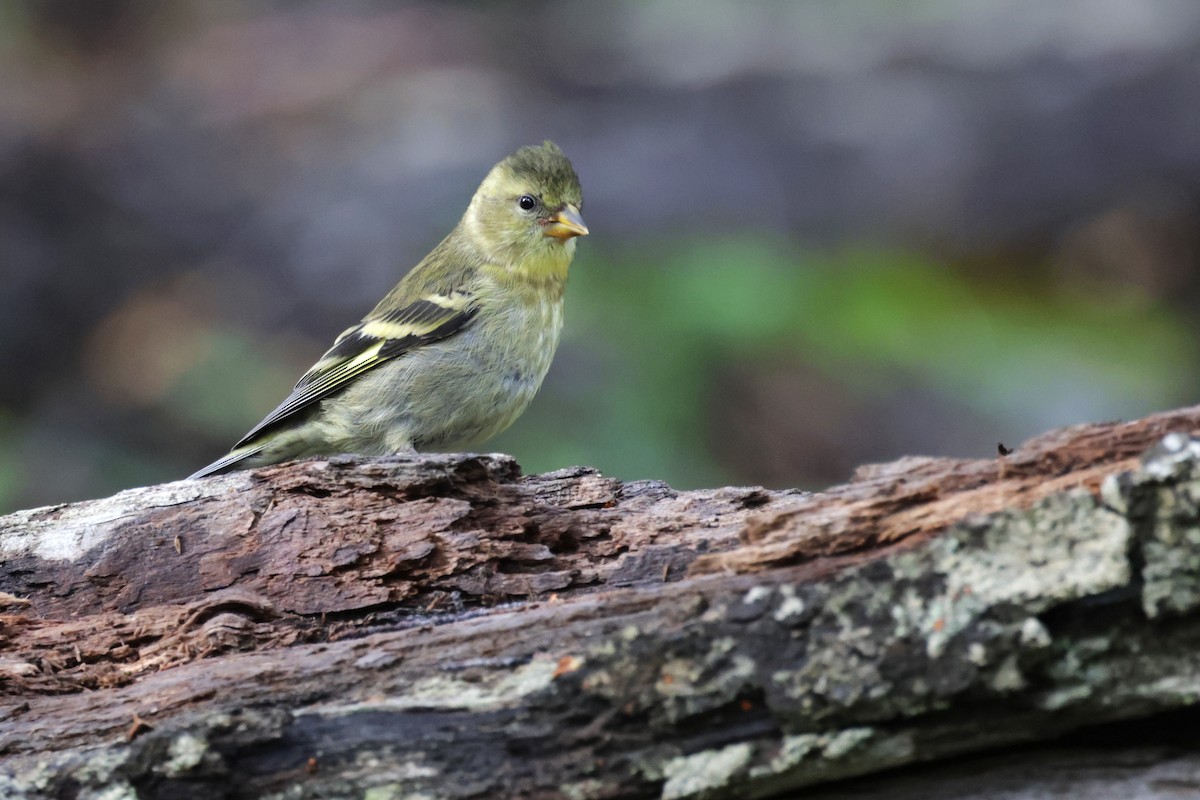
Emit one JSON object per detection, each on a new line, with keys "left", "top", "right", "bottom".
{"left": 0, "top": 408, "right": 1200, "bottom": 800}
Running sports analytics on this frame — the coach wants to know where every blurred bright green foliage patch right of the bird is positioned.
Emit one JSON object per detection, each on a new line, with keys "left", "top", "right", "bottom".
{"left": 492, "top": 236, "right": 1195, "bottom": 487}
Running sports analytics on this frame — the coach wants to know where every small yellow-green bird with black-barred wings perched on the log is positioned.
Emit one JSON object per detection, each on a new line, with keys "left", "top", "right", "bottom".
{"left": 191, "top": 142, "right": 588, "bottom": 477}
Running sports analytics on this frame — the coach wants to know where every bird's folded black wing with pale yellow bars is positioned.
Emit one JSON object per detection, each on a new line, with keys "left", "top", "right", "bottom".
{"left": 234, "top": 291, "right": 479, "bottom": 450}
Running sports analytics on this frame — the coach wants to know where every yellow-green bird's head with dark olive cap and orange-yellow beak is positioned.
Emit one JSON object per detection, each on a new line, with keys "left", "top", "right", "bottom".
{"left": 464, "top": 142, "right": 588, "bottom": 280}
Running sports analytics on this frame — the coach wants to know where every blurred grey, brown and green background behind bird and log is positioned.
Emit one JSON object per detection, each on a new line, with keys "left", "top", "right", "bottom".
{"left": 0, "top": 0, "right": 1200, "bottom": 511}
